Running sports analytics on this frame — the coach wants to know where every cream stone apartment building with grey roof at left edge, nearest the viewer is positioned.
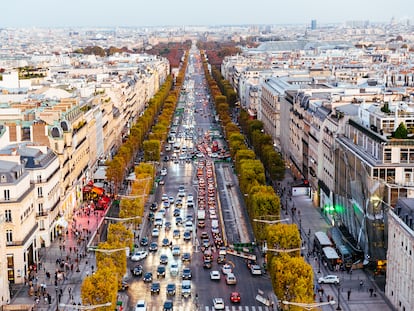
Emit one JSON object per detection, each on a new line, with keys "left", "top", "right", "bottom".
{"left": 0, "top": 143, "right": 62, "bottom": 300}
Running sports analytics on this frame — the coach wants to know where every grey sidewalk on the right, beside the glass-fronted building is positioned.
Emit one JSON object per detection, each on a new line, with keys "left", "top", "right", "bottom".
{"left": 281, "top": 170, "right": 392, "bottom": 311}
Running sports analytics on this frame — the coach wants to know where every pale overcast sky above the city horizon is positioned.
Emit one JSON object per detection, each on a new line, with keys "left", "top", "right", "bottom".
{"left": 4, "top": 0, "right": 414, "bottom": 28}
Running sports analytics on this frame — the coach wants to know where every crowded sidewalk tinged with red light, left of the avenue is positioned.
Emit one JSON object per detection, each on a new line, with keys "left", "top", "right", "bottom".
{"left": 11, "top": 209, "right": 113, "bottom": 310}
